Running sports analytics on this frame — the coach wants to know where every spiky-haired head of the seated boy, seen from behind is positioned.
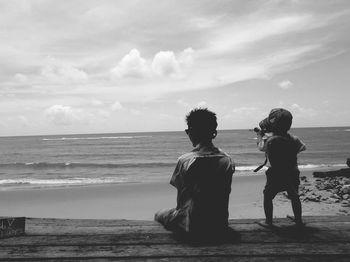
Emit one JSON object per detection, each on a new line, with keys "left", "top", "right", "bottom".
{"left": 186, "top": 108, "right": 218, "bottom": 146}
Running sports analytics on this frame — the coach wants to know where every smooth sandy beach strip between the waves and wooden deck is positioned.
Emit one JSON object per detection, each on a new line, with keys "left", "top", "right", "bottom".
{"left": 0, "top": 167, "right": 343, "bottom": 220}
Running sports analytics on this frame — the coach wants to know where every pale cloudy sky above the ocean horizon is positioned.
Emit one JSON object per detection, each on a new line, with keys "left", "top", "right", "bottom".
{"left": 0, "top": 0, "right": 350, "bottom": 136}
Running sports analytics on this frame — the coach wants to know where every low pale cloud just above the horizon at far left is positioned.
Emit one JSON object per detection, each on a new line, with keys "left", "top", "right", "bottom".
{"left": 45, "top": 105, "right": 86, "bottom": 126}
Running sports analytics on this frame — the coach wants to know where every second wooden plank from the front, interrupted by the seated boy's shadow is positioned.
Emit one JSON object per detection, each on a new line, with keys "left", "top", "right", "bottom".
{"left": 0, "top": 231, "right": 350, "bottom": 247}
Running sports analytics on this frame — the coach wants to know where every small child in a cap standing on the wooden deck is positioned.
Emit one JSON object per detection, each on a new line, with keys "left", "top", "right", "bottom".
{"left": 255, "top": 108, "right": 306, "bottom": 226}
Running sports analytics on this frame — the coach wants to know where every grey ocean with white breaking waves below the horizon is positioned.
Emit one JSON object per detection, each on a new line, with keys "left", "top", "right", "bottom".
{"left": 0, "top": 127, "right": 350, "bottom": 190}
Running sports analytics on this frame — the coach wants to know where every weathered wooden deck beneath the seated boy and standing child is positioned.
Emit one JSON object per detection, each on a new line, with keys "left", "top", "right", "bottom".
{"left": 0, "top": 216, "right": 350, "bottom": 262}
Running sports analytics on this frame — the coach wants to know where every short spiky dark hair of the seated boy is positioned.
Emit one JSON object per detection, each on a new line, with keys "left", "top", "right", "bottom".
{"left": 186, "top": 108, "right": 218, "bottom": 138}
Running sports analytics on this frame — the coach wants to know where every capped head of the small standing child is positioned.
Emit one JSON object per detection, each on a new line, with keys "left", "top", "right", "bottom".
{"left": 259, "top": 108, "right": 293, "bottom": 134}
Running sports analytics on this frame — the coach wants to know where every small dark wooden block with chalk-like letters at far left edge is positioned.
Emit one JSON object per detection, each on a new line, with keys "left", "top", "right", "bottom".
{"left": 0, "top": 217, "right": 25, "bottom": 239}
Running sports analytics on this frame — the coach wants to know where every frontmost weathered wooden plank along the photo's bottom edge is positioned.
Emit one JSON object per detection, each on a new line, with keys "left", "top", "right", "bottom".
{"left": 0, "top": 243, "right": 350, "bottom": 260}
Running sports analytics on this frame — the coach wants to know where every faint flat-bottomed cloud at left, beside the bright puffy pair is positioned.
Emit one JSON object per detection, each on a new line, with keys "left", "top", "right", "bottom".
{"left": 41, "top": 59, "right": 89, "bottom": 83}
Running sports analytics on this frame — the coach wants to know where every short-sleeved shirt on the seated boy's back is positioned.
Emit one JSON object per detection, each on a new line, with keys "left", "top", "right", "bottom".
{"left": 170, "top": 147, "right": 235, "bottom": 232}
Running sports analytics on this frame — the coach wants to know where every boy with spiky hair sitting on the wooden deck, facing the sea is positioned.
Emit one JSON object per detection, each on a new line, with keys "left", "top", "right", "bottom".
{"left": 155, "top": 109, "right": 234, "bottom": 238}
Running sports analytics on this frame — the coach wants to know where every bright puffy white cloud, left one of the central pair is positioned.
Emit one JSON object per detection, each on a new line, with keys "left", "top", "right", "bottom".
{"left": 111, "top": 49, "right": 149, "bottom": 78}
